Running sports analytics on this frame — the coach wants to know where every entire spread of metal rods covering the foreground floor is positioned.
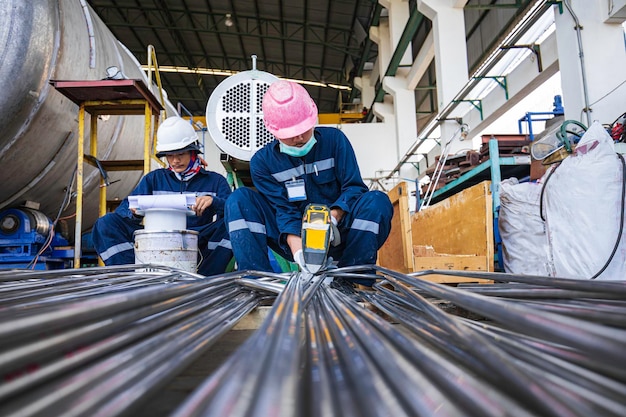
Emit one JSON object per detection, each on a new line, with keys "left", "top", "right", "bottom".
{"left": 0, "top": 266, "right": 626, "bottom": 417}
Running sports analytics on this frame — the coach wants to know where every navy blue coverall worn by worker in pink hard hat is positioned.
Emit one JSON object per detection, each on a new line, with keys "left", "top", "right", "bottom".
{"left": 224, "top": 127, "right": 393, "bottom": 278}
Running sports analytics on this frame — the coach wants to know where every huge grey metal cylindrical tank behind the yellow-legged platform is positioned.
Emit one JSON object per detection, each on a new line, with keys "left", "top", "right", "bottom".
{"left": 0, "top": 0, "right": 174, "bottom": 237}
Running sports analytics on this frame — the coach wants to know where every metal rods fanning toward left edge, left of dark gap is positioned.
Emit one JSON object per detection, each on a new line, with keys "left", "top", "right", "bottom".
{"left": 0, "top": 265, "right": 274, "bottom": 416}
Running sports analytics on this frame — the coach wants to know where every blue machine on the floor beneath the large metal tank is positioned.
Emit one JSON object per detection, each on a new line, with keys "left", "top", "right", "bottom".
{"left": 0, "top": 208, "right": 74, "bottom": 270}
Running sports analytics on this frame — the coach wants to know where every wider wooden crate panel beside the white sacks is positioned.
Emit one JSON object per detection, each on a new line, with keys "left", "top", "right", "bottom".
{"left": 411, "top": 181, "right": 494, "bottom": 282}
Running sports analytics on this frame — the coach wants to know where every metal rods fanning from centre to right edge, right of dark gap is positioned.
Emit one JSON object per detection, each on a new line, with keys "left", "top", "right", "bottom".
{"left": 173, "top": 266, "right": 626, "bottom": 417}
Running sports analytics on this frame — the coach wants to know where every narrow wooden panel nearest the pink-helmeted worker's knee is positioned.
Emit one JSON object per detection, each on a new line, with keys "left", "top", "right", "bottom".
{"left": 378, "top": 182, "right": 414, "bottom": 274}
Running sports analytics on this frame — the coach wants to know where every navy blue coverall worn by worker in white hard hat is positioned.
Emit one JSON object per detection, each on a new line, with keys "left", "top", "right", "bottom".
{"left": 92, "top": 168, "right": 233, "bottom": 276}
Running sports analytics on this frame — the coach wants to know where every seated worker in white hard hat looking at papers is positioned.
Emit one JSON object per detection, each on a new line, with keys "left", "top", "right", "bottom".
{"left": 92, "top": 116, "right": 232, "bottom": 276}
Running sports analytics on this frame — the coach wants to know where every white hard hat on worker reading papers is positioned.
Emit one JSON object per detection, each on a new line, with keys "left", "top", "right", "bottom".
{"left": 156, "top": 116, "right": 201, "bottom": 158}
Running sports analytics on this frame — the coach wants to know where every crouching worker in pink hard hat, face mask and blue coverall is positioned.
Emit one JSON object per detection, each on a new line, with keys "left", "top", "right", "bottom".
{"left": 225, "top": 80, "right": 393, "bottom": 285}
